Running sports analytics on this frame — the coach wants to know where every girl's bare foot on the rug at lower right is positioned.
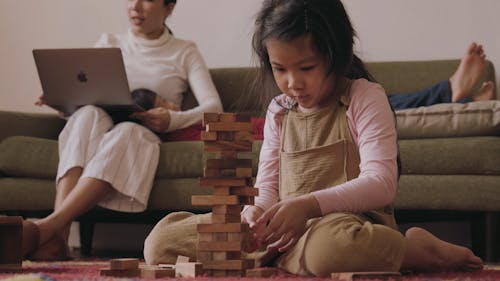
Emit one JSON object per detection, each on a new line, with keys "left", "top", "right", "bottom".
{"left": 402, "top": 227, "right": 483, "bottom": 272}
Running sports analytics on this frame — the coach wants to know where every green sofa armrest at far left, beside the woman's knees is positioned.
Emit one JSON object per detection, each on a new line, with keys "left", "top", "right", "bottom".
{"left": 0, "top": 111, "right": 66, "bottom": 141}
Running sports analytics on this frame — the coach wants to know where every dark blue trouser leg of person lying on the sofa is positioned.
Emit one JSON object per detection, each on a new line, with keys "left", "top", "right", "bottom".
{"left": 389, "top": 80, "right": 472, "bottom": 110}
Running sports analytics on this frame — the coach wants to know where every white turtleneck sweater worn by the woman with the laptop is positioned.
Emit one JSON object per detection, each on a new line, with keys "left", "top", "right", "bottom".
{"left": 95, "top": 29, "right": 222, "bottom": 132}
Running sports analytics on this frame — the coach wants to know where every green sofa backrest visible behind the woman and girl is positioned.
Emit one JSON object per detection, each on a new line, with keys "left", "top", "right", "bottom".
{"left": 182, "top": 60, "right": 499, "bottom": 116}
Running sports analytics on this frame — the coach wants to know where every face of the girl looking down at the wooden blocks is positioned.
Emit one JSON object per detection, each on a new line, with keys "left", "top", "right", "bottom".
{"left": 265, "top": 36, "right": 335, "bottom": 108}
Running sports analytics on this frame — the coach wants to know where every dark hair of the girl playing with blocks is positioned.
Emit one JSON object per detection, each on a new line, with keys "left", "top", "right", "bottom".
{"left": 252, "top": 0, "right": 374, "bottom": 105}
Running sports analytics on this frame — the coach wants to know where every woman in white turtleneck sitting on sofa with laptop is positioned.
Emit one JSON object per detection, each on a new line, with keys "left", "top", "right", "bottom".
{"left": 23, "top": 0, "right": 222, "bottom": 260}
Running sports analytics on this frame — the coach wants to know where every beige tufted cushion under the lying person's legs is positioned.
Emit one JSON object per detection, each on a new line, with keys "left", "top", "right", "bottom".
{"left": 396, "top": 100, "right": 500, "bottom": 139}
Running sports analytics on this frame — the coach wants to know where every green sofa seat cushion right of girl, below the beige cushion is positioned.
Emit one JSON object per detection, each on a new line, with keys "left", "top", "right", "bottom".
{"left": 399, "top": 137, "right": 500, "bottom": 175}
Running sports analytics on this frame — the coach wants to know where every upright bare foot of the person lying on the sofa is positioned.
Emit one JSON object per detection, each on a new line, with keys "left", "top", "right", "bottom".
{"left": 450, "top": 43, "right": 486, "bottom": 102}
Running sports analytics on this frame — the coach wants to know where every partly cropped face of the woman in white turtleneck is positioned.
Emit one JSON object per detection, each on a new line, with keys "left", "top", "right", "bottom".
{"left": 127, "top": 0, "right": 175, "bottom": 39}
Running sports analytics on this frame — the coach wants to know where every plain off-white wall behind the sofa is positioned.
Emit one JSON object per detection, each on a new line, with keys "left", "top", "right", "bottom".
{"left": 0, "top": 0, "right": 500, "bottom": 112}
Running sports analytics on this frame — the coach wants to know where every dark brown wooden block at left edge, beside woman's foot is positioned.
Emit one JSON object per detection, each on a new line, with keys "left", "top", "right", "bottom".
{"left": 0, "top": 216, "right": 23, "bottom": 271}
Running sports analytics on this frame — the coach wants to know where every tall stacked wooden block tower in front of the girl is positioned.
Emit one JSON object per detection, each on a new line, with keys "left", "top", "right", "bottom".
{"left": 192, "top": 113, "right": 258, "bottom": 277}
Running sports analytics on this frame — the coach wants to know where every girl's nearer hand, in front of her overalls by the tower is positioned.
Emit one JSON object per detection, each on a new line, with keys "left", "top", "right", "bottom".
{"left": 256, "top": 194, "right": 321, "bottom": 252}
